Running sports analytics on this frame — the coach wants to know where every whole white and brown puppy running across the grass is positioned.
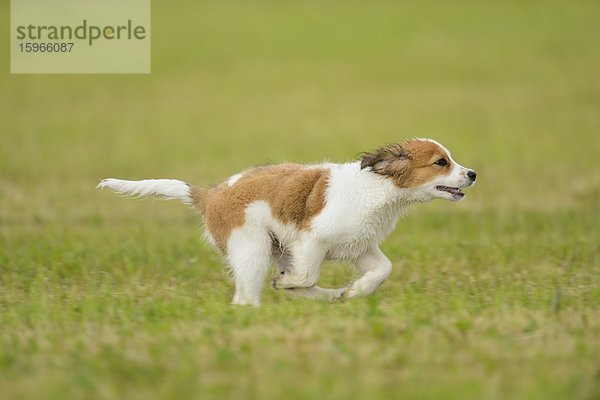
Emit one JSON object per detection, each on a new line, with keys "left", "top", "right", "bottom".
{"left": 98, "top": 139, "right": 476, "bottom": 306}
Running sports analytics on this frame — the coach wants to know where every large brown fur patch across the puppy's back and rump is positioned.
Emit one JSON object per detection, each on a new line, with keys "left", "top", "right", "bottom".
{"left": 190, "top": 164, "right": 329, "bottom": 250}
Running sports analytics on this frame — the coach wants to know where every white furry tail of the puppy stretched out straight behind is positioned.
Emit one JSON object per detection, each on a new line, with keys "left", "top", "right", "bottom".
{"left": 96, "top": 178, "right": 192, "bottom": 204}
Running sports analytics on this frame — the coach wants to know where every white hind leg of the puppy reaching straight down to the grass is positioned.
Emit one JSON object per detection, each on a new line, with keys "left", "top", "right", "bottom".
{"left": 227, "top": 224, "right": 271, "bottom": 306}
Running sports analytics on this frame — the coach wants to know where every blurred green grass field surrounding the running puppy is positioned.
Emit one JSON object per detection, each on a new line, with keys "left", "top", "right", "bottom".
{"left": 0, "top": 0, "right": 600, "bottom": 400}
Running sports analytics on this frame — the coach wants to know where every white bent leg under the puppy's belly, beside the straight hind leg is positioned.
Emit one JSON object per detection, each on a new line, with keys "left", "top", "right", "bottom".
{"left": 272, "top": 238, "right": 327, "bottom": 289}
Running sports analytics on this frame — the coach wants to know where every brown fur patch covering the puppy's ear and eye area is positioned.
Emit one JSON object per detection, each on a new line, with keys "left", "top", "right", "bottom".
{"left": 360, "top": 139, "right": 452, "bottom": 188}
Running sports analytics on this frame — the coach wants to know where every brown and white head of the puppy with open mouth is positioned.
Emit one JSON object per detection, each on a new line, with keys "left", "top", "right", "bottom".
{"left": 360, "top": 139, "right": 477, "bottom": 201}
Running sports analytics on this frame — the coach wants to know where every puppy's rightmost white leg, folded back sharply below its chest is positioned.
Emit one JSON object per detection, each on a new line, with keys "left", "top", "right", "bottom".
{"left": 343, "top": 247, "right": 392, "bottom": 299}
